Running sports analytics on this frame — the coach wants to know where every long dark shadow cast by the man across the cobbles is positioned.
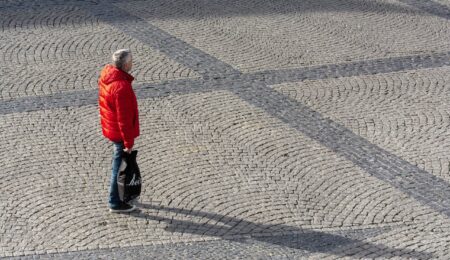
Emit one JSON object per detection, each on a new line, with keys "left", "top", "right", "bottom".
{"left": 132, "top": 204, "right": 433, "bottom": 259}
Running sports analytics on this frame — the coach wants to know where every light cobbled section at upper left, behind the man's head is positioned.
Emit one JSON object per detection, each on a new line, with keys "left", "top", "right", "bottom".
{"left": 0, "top": 2, "right": 198, "bottom": 100}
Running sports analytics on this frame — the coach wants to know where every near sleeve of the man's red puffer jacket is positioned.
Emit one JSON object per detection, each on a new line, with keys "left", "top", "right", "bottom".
{"left": 115, "top": 83, "right": 136, "bottom": 149}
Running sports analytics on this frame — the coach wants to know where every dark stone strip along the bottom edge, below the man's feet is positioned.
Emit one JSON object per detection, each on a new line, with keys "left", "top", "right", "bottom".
{"left": 4, "top": 224, "right": 394, "bottom": 259}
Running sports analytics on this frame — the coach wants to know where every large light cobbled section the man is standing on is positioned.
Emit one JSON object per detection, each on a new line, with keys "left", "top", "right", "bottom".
{"left": 1, "top": 92, "right": 447, "bottom": 254}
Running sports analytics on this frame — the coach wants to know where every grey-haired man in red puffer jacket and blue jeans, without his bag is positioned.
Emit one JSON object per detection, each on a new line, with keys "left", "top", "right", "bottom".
{"left": 98, "top": 49, "right": 139, "bottom": 213}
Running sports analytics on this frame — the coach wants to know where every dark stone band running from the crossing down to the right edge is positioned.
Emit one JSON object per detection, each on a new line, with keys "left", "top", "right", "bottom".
{"left": 235, "top": 86, "right": 450, "bottom": 217}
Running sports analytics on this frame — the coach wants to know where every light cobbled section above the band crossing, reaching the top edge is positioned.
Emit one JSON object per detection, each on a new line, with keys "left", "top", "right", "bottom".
{"left": 116, "top": 0, "right": 449, "bottom": 73}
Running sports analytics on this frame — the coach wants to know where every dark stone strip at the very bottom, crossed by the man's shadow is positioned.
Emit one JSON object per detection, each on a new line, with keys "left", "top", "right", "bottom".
{"left": 7, "top": 224, "right": 400, "bottom": 260}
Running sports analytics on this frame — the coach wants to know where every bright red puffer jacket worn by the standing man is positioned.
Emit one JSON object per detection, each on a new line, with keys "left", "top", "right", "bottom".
{"left": 98, "top": 65, "right": 139, "bottom": 149}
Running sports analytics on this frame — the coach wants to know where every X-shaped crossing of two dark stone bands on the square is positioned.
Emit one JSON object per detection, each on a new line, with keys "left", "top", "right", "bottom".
{"left": 0, "top": 1, "right": 450, "bottom": 256}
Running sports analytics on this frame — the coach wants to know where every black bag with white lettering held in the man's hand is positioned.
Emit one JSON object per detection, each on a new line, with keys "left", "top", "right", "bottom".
{"left": 117, "top": 150, "right": 142, "bottom": 202}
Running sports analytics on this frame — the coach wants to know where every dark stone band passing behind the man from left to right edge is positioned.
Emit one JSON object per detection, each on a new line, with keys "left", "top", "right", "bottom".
{"left": 0, "top": 52, "right": 450, "bottom": 115}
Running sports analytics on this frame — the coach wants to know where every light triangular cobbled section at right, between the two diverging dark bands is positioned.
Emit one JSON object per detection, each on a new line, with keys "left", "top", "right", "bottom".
{"left": 274, "top": 67, "right": 449, "bottom": 182}
